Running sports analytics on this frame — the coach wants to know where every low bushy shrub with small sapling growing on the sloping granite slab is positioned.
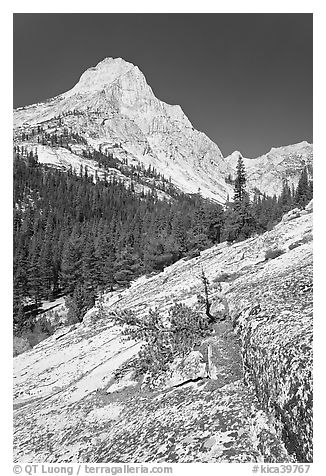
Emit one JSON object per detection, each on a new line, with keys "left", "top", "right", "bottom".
{"left": 108, "top": 269, "right": 227, "bottom": 377}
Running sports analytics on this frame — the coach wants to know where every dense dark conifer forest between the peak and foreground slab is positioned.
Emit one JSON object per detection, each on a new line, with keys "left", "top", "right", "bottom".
{"left": 14, "top": 150, "right": 312, "bottom": 333}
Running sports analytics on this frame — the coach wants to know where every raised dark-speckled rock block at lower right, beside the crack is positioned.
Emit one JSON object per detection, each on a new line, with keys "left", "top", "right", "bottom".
{"left": 228, "top": 238, "right": 313, "bottom": 462}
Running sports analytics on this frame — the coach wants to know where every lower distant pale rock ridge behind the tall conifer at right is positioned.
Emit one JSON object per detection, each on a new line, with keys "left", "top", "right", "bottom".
{"left": 225, "top": 141, "right": 313, "bottom": 196}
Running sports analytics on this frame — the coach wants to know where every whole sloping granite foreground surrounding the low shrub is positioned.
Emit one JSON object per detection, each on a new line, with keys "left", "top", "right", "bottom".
{"left": 14, "top": 213, "right": 312, "bottom": 462}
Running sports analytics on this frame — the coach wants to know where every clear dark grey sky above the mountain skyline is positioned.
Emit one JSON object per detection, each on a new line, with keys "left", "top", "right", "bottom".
{"left": 14, "top": 13, "right": 312, "bottom": 157}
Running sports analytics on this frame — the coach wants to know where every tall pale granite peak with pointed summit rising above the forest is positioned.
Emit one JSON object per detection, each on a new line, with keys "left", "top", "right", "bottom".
{"left": 14, "top": 58, "right": 232, "bottom": 202}
